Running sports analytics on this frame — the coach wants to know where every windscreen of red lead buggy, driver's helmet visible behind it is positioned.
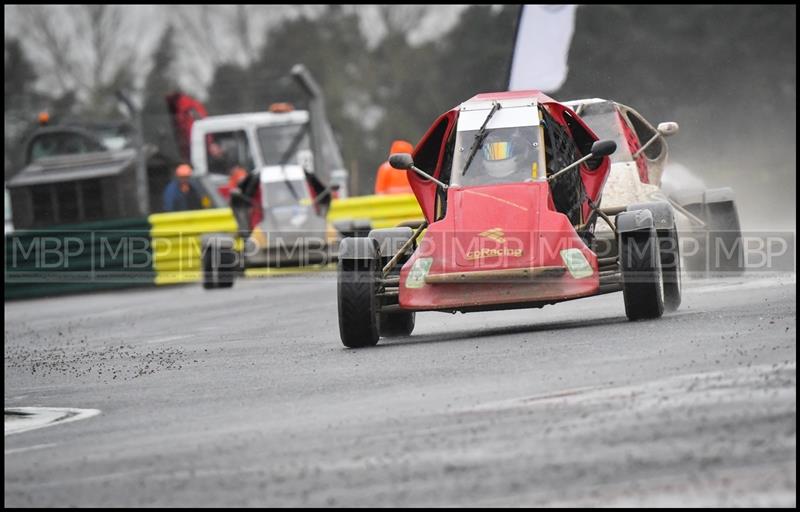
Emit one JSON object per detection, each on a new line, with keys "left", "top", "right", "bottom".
{"left": 451, "top": 124, "right": 546, "bottom": 186}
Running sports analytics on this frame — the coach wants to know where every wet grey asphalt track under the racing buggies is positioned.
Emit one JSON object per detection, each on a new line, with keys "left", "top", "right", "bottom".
{"left": 4, "top": 275, "right": 797, "bottom": 506}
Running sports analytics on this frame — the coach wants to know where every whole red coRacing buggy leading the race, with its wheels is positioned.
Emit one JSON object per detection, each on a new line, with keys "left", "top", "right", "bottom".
{"left": 338, "top": 91, "right": 680, "bottom": 347}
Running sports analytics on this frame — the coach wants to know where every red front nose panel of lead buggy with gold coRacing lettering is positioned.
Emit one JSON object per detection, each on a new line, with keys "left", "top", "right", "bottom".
{"left": 400, "top": 182, "right": 599, "bottom": 310}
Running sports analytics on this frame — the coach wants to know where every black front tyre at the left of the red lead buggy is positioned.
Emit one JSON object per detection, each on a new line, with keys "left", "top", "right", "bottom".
{"left": 338, "top": 258, "right": 380, "bottom": 348}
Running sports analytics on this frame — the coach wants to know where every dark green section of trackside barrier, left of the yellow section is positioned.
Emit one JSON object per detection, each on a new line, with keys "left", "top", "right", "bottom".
{"left": 4, "top": 218, "right": 155, "bottom": 300}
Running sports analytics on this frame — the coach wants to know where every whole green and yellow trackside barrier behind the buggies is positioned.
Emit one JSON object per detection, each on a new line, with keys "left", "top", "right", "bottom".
{"left": 5, "top": 194, "right": 423, "bottom": 299}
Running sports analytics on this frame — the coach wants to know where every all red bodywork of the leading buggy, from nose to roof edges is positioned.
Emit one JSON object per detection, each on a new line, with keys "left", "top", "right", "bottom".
{"left": 399, "top": 91, "right": 610, "bottom": 311}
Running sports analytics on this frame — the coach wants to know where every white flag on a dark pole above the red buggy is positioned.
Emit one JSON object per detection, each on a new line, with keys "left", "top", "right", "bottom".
{"left": 508, "top": 5, "right": 576, "bottom": 92}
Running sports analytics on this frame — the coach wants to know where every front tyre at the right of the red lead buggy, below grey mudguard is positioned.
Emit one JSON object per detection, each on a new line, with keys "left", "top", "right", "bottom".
{"left": 619, "top": 227, "right": 664, "bottom": 320}
